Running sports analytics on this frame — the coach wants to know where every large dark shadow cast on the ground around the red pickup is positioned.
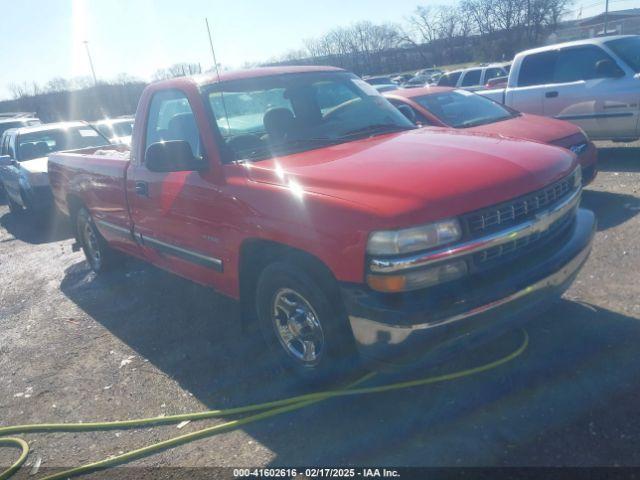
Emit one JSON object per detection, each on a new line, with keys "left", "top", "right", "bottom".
{"left": 61, "top": 261, "right": 640, "bottom": 466}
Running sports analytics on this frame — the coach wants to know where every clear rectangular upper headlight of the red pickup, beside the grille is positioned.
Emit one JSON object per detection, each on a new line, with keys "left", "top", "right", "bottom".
{"left": 367, "top": 218, "right": 462, "bottom": 255}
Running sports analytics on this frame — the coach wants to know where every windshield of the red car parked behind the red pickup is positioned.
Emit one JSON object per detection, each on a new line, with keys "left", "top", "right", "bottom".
{"left": 413, "top": 90, "right": 514, "bottom": 128}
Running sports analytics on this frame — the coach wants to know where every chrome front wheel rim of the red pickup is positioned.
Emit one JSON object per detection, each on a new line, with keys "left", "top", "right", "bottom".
{"left": 272, "top": 288, "right": 324, "bottom": 367}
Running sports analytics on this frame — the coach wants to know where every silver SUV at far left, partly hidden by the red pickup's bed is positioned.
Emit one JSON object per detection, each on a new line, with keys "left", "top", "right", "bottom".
{"left": 0, "top": 122, "right": 109, "bottom": 213}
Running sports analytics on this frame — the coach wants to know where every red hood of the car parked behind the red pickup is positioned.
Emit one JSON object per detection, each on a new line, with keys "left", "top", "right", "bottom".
{"left": 467, "top": 113, "right": 580, "bottom": 143}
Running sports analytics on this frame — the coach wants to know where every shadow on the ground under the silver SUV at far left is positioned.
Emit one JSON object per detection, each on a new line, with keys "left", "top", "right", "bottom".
{"left": 0, "top": 212, "right": 73, "bottom": 244}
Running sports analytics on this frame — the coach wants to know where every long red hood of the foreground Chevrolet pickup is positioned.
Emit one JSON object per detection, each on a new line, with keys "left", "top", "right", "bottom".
{"left": 248, "top": 128, "right": 577, "bottom": 227}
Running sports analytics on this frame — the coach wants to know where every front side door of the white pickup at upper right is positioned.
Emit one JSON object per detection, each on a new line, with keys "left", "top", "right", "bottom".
{"left": 543, "top": 45, "right": 638, "bottom": 140}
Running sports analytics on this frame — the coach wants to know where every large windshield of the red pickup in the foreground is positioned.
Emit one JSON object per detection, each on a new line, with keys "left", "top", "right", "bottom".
{"left": 204, "top": 72, "right": 414, "bottom": 160}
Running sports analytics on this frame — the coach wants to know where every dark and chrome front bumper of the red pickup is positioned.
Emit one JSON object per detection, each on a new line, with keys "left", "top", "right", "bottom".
{"left": 342, "top": 209, "right": 596, "bottom": 363}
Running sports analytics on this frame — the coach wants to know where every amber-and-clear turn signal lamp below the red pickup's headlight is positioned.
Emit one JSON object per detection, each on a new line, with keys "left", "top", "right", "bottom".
{"left": 367, "top": 260, "right": 467, "bottom": 293}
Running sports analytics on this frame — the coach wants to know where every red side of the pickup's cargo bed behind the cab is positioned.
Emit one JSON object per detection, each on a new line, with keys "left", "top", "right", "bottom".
{"left": 49, "top": 145, "right": 131, "bottom": 237}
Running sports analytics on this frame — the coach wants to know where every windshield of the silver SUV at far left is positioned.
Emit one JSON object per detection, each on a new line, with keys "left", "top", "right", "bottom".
{"left": 18, "top": 126, "right": 109, "bottom": 161}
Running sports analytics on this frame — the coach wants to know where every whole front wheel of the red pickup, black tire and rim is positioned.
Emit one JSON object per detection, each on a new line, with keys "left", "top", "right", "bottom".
{"left": 256, "top": 261, "right": 359, "bottom": 383}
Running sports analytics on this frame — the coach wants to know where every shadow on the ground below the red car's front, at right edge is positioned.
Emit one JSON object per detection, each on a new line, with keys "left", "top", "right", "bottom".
{"left": 581, "top": 189, "right": 640, "bottom": 231}
